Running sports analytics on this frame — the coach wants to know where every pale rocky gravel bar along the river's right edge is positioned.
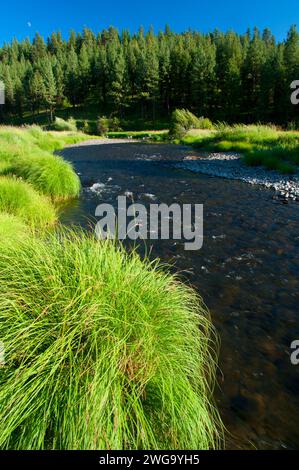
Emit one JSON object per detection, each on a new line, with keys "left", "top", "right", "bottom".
{"left": 175, "top": 153, "right": 299, "bottom": 201}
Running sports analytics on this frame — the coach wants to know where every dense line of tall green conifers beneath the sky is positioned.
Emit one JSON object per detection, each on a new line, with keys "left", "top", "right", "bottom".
{"left": 0, "top": 26, "right": 299, "bottom": 123}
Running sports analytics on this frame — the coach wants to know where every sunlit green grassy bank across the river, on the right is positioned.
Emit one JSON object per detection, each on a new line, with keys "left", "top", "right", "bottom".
{"left": 180, "top": 125, "right": 299, "bottom": 174}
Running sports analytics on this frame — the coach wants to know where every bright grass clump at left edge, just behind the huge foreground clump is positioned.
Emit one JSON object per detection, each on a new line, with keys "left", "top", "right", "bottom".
{"left": 0, "top": 177, "right": 57, "bottom": 228}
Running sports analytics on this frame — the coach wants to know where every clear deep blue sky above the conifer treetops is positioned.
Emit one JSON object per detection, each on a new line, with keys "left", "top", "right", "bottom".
{"left": 0, "top": 0, "right": 299, "bottom": 44}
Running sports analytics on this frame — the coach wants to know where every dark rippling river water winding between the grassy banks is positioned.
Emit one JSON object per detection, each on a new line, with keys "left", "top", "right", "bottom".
{"left": 63, "top": 144, "right": 299, "bottom": 449}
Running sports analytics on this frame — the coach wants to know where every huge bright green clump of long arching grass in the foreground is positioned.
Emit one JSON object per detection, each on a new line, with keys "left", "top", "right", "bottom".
{"left": 0, "top": 232, "right": 221, "bottom": 450}
